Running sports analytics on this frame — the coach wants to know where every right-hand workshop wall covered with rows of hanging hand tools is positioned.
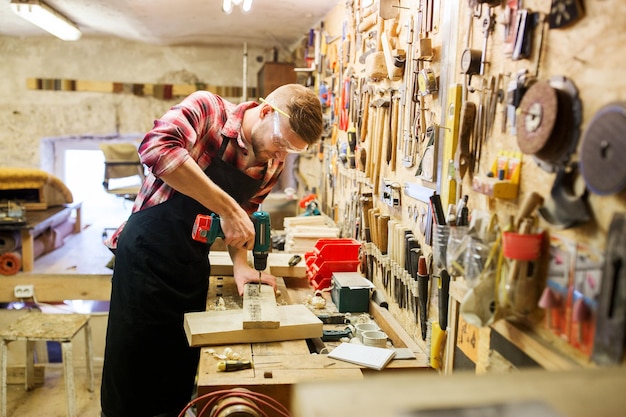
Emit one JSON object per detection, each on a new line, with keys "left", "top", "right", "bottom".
{"left": 301, "top": 0, "right": 626, "bottom": 371}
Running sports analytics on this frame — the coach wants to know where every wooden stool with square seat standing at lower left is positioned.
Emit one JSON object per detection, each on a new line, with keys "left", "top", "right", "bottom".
{"left": 0, "top": 312, "right": 94, "bottom": 417}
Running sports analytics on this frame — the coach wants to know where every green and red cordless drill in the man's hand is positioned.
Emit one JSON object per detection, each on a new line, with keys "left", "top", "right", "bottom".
{"left": 191, "top": 211, "right": 271, "bottom": 276}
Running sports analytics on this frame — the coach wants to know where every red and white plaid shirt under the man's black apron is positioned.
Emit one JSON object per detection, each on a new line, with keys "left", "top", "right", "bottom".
{"left": 106, "top": 91, "right": 284, "bottom": 249}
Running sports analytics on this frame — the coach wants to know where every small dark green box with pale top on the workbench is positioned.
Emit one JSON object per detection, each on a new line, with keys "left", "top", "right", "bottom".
{"left": 331, "top": 272, "right": 374, "bottom": 313}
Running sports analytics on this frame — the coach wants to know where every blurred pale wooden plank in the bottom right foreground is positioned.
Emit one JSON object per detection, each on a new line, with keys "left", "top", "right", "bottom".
{"left": 292, "top": 367, "right": 626, "bottom": 417}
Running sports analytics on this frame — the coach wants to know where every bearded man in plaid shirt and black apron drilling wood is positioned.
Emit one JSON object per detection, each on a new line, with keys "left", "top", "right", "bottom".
{"left": 101, "top": 84, "right": 323, "bottom": 417}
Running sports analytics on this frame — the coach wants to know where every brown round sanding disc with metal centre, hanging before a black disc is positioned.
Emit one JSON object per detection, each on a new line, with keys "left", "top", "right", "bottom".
{"left": 517, "top": 81, "right": 571, "bottom": 161}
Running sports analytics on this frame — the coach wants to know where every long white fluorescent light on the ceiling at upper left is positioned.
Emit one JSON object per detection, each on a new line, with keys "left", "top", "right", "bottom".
{"left": 11, "top": 0, "right": 81, "bottom": 41}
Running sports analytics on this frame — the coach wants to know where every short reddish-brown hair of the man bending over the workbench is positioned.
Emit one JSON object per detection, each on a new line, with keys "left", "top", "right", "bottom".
{"left": 267, "top": 84, "right": 324, "bottom": 145}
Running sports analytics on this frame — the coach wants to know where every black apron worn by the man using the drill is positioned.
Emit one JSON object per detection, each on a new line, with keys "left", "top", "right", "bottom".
{"left": 101, "top": 138, "right": 262, "bottom": 417}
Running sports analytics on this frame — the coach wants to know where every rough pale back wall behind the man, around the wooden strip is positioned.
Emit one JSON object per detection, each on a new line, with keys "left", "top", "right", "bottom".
{"left": 0, "top": 36, "right": 272, "bottom": 168}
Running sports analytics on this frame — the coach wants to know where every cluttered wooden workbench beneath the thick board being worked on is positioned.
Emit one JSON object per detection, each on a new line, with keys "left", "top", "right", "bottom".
{"left": 197, "top": 254, "right": 434, "bottom": 408}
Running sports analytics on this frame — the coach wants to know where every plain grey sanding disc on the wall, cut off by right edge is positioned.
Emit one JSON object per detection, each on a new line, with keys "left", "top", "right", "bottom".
{"left": 580, "top": 103, "right": 626, "bottom": 195}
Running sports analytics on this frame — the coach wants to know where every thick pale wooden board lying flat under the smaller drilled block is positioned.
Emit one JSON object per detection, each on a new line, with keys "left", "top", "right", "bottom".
{"left": 184, "top": 304, "right": 322, "bottom": 346}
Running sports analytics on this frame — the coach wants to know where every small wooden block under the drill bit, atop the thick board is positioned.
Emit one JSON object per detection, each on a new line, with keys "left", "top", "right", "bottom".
{"left": 242, "top": 283, "right": 280, "bottom": 329}
